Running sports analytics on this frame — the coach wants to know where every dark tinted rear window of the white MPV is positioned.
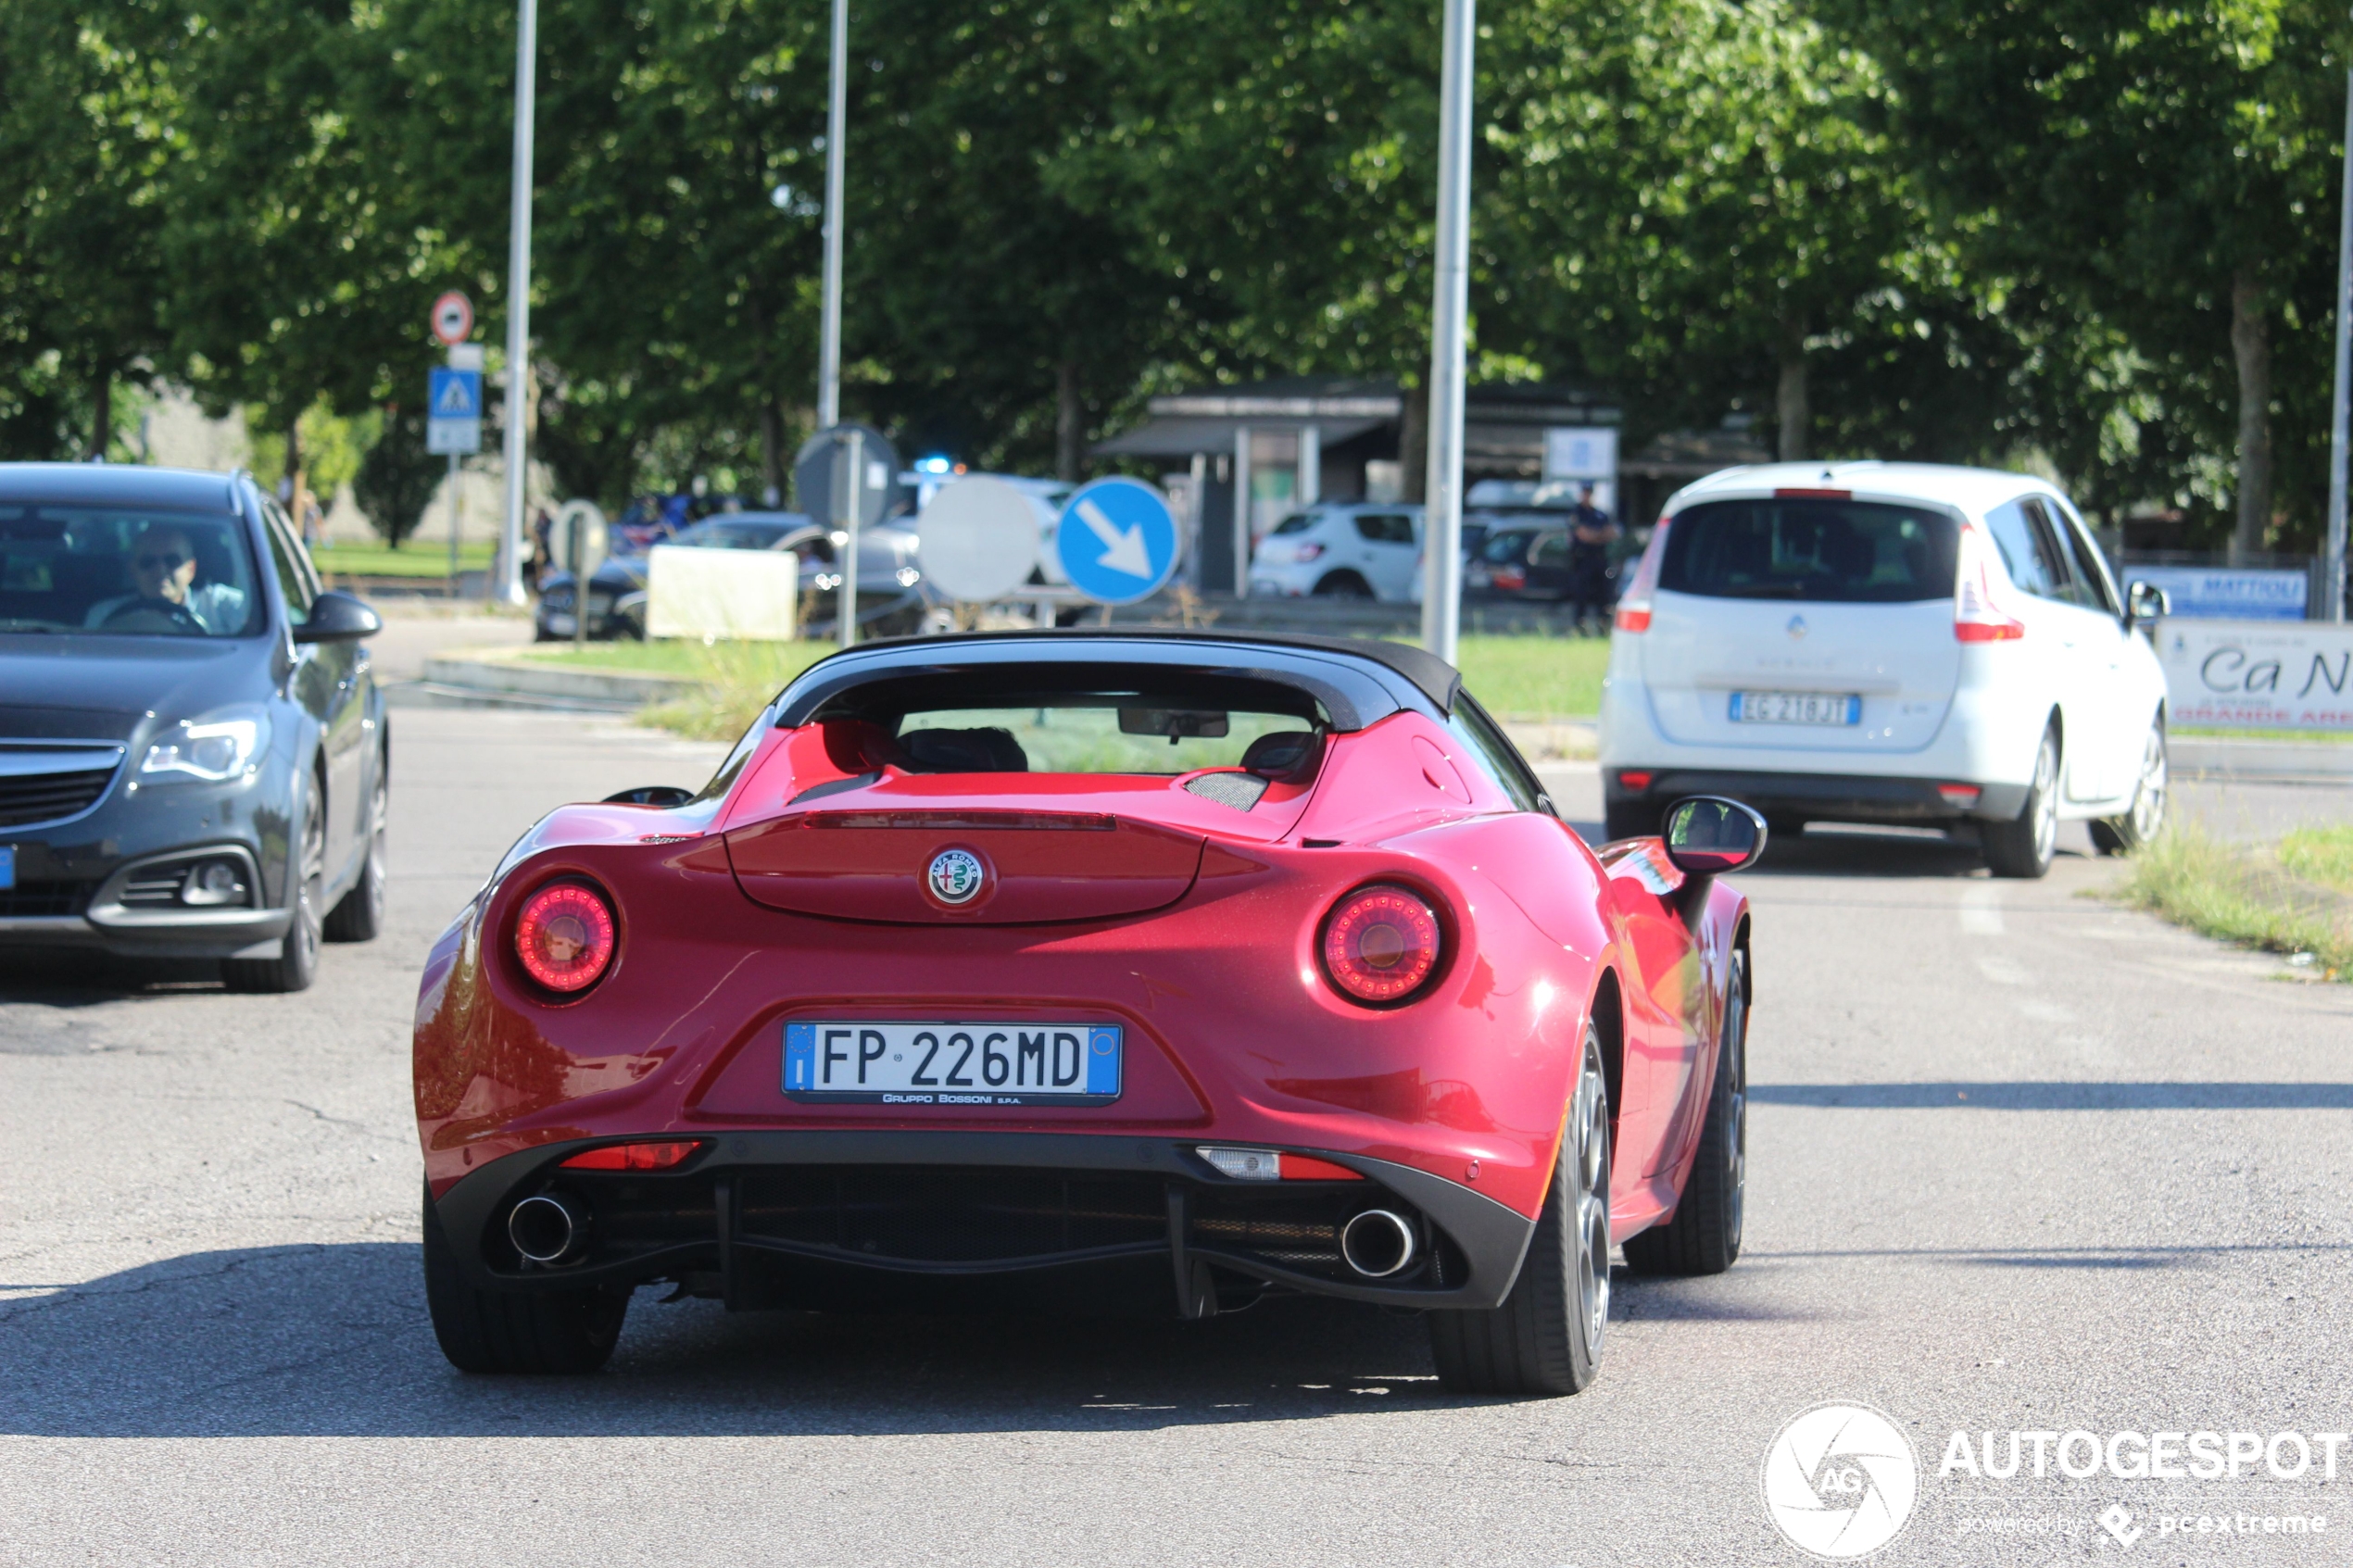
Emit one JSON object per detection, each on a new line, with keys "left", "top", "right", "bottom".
{"left": 1659, "top": 498, "right": 1960, "bottom": 604}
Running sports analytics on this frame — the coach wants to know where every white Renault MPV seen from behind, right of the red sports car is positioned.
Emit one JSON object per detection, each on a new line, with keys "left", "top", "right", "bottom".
{"left": 1600, "top": 463, "right": 2165, "bottom": 877}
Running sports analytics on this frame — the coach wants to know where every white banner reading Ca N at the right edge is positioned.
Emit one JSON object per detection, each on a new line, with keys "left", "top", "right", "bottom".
{"left": 2156, "top": 621, "right": 2353, "bottom": 729}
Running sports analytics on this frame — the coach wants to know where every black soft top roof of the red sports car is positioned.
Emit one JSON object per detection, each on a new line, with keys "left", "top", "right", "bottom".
{"left": 776, "top": 628, "right": 1461, "bottom": 729}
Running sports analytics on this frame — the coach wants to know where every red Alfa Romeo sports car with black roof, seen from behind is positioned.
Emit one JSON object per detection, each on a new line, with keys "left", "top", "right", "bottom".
{"left": 417, "top": 633, "right": 1765, "bottom": 1394}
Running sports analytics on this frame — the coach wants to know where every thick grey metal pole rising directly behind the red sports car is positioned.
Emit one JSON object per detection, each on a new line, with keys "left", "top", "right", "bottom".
{"left": 1421, "top": 0, "right": 1478, "bottom": 663}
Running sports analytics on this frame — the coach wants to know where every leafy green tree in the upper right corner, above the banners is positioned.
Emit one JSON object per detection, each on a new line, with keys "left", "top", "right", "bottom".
{"left": 1818, "top": 0, "right": 2346, "bottom": 550}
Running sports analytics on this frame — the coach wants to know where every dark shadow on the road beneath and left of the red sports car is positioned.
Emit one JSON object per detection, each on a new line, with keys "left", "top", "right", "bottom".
{"left": 0, "top": 1244, "right": 1647, "bottom": 1436}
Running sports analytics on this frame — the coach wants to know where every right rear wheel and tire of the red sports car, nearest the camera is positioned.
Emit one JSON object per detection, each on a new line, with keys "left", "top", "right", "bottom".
{"left": 1428, "top": 1022, "right": 1609, "bottom": 1397}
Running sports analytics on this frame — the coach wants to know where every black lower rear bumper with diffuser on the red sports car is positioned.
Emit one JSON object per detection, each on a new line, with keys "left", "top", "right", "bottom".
{"left": 437, "top": 1128, "right": 1534, "bottom": 1316}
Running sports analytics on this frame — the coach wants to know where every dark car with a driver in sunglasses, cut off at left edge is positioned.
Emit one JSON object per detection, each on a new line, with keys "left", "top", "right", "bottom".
{"left": 0, "top": 463, "right": 391, "bottom": 992}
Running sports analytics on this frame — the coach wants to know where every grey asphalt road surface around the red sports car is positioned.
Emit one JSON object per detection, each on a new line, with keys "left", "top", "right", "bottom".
{"left": 0, "top": 710, "right": 2353, "bottom": 1568}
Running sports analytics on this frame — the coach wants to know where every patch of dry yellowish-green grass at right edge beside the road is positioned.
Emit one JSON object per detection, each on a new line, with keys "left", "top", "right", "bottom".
{"left": 2118, "top": 822, "right": 2353, "bottom": 980}
